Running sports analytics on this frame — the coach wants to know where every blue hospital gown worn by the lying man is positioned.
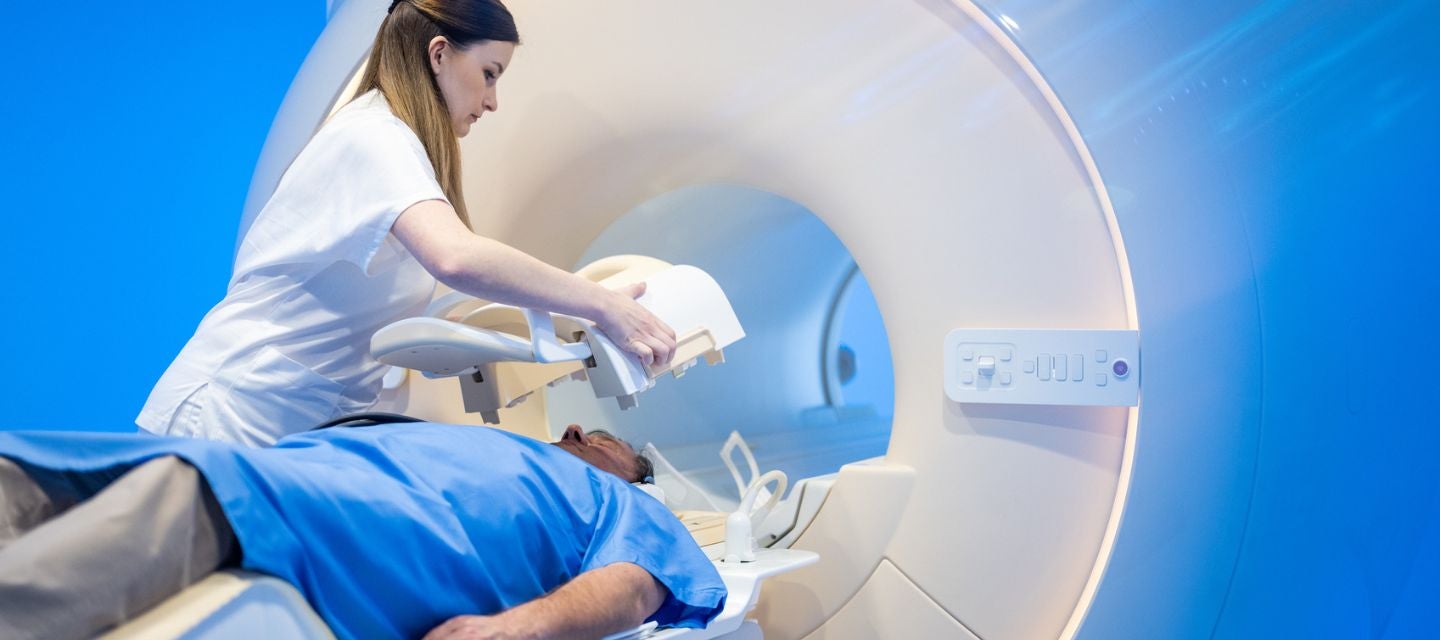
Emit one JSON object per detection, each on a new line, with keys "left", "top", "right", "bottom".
{"left": 0, "top": 424, "right": 726, "bottom": 639}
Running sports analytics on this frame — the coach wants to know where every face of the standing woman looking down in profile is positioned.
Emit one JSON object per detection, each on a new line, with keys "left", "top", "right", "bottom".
{"left": 429, "top": 36, "right": 516, "bottom": 138}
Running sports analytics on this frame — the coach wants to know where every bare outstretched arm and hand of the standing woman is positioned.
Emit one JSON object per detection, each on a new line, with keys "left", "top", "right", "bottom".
{"left": 390, "top": 200, "right": 675, "bottom": 365}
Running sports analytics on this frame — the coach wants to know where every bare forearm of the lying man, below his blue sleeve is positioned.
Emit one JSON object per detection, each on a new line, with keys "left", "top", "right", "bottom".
{"left": 425, "top": 562, "right": 665, "bottom": 640}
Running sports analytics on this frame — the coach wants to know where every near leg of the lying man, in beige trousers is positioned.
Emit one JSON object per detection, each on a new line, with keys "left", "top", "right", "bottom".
{"left": 0, "top": 457, "right": 235, "bottom": 639}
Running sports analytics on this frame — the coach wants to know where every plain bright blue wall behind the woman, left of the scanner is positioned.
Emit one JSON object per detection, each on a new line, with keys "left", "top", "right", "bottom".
{"left": 0, "top": 0, "right": 325, "bottom": 431}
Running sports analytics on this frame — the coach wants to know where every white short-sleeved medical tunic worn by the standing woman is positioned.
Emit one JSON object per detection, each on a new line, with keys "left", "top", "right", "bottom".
{"left": 135, "top": 91, "right": 445, "bottom": 445}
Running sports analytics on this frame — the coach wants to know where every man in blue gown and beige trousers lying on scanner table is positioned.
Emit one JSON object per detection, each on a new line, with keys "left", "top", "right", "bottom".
{"left": 0, "top": 422, "right": 726, "bottom": 639}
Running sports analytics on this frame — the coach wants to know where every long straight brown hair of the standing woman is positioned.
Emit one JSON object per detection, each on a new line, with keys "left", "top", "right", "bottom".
{"left": 350, "top": 0, "right": 520, "bottom": 226}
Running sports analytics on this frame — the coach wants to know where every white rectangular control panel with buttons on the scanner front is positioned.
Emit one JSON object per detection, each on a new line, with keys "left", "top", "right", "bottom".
{"left": 945, "top": 329, "right": 1140, "bottom": 406}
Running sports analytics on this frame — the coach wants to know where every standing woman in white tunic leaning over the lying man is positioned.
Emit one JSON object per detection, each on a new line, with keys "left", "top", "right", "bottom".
{"left": 135, "top": 0, "right": 675, "bottom": 445}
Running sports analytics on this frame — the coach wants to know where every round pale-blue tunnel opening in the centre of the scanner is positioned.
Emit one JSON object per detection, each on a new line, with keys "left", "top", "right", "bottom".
{"left": 547, "top": 185, "right": 894, "bottom": 507}
